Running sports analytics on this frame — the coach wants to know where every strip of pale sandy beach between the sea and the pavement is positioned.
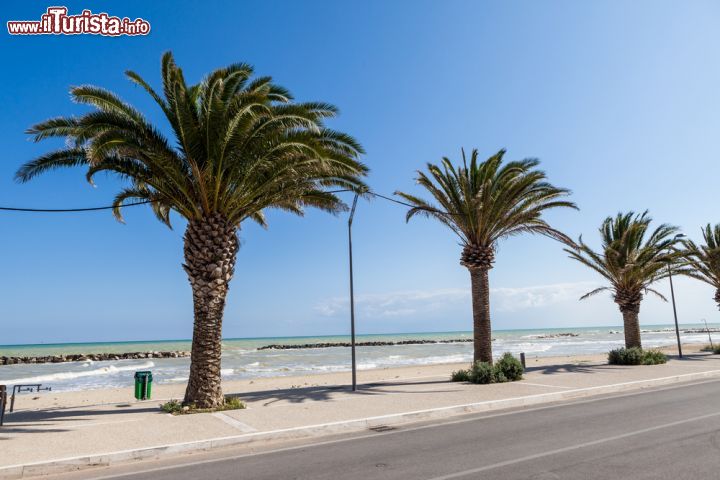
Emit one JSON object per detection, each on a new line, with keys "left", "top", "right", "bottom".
{"left": 8, "top": 344, "right": 705, "bottom": 411}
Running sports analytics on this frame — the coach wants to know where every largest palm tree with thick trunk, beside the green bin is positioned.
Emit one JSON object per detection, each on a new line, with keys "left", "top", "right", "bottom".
{"left": 17, "top": 52, "right": 367, "bottom": 408}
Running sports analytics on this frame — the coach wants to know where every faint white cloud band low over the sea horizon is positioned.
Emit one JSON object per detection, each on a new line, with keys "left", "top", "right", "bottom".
{"left": 315, "top": 282, "right": 598, "bottom": 318}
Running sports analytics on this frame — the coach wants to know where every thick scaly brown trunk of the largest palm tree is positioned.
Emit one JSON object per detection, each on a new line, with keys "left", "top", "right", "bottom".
{"left": 183, "top": 214, "right": 239, "bottom": 408}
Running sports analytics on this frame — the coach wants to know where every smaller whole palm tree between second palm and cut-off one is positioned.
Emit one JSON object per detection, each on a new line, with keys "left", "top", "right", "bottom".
{"left": 565, "top": 211, "right": 680, "bottom": 348}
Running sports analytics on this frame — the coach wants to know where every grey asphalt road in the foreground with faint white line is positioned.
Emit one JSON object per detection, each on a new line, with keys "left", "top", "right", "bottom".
{"left": 63, "top": 380, "right": 720, "bottom": 480}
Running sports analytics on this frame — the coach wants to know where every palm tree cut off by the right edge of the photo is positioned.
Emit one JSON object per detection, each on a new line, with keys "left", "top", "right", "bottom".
{"left": 683, "top": 223, "right": 720, "bottom": 308}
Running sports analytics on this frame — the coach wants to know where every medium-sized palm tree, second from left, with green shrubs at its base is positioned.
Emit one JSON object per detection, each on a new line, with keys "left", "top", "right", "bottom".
{"left": 396, "top": 150, "right": 577, "bottom": 363}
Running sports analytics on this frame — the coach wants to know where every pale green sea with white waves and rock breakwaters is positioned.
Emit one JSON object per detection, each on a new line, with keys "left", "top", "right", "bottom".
{"left": 0, "top": 324, "right": 720, "bottom": 391}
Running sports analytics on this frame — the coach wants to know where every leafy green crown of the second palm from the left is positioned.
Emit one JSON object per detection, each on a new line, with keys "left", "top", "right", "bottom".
{"left": 396, "top": 150, "right": 577, "bottom": 256}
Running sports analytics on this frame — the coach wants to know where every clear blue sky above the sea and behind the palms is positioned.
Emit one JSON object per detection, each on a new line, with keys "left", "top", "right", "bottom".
{"left": 0, "top": 0, "right": 720, "bottom": 344}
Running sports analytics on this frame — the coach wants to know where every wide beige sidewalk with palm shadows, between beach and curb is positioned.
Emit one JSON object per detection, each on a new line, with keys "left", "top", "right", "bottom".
{"left": 0, "top": 354, "right": 720, "bottom": 479}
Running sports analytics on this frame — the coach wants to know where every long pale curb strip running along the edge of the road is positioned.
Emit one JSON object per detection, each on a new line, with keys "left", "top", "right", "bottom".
{"left": 0, "top": 370, "right": 720, "bottom": 480}
